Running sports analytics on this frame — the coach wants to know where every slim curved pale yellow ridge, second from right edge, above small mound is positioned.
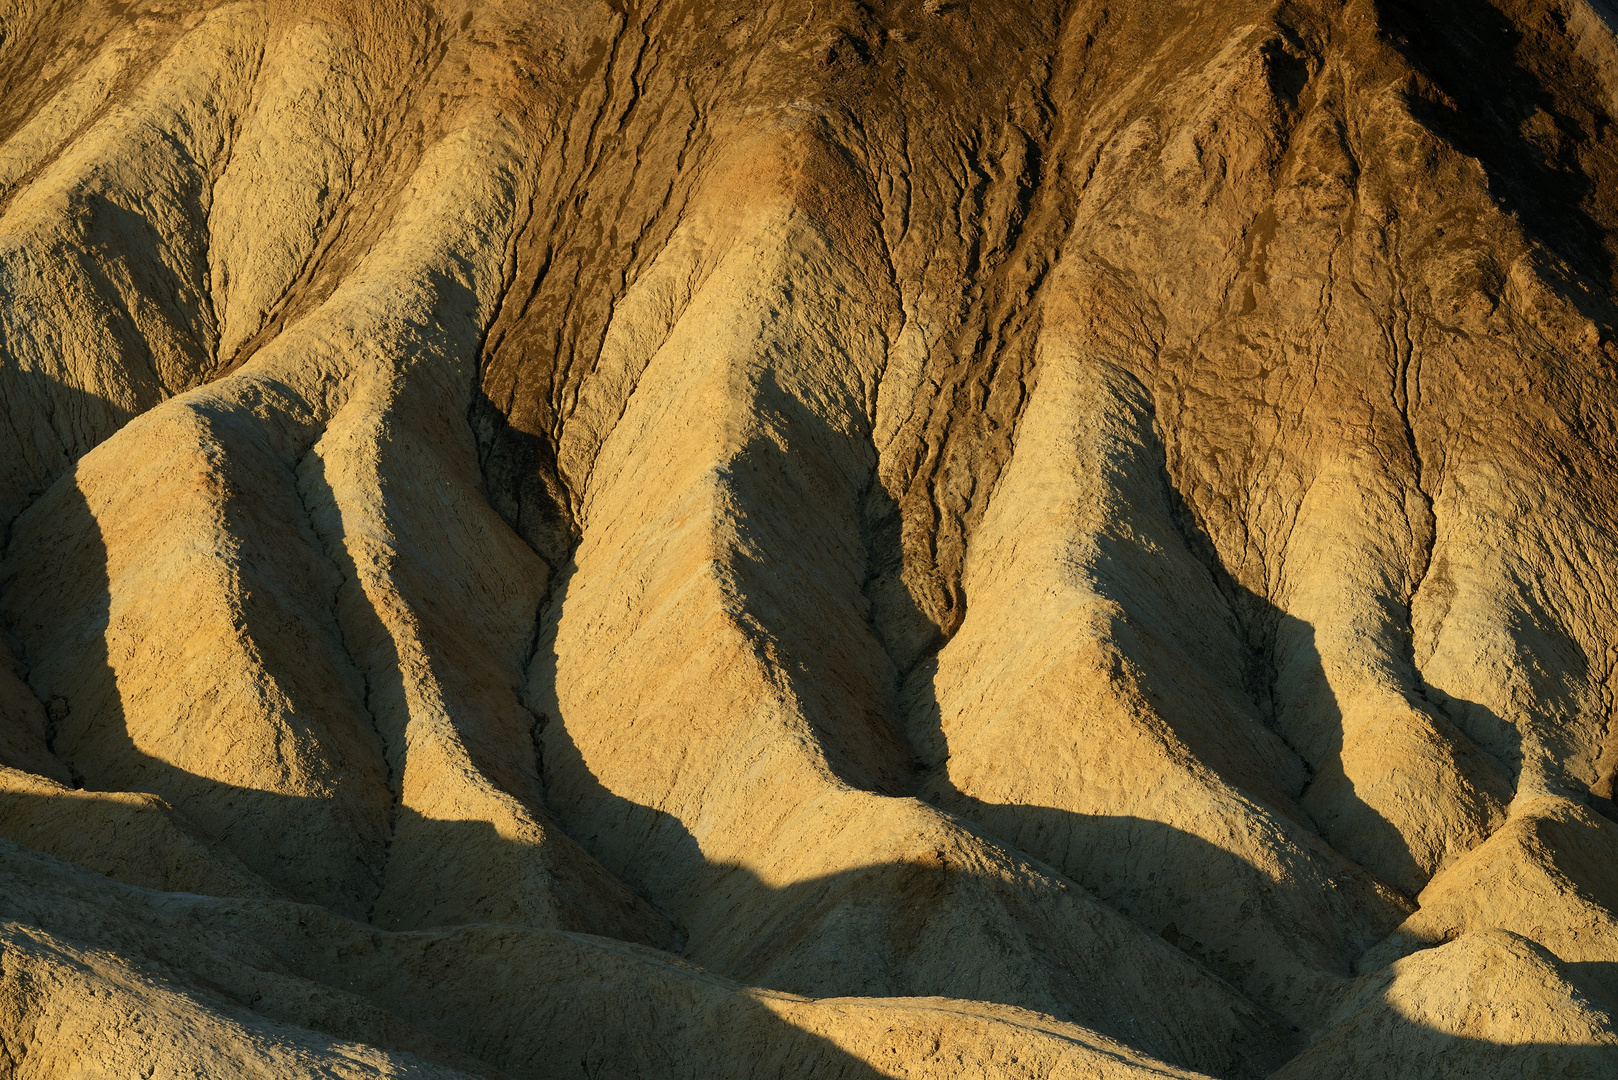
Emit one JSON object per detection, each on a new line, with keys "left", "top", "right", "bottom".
{"left": 1275, "top": 461, "right": 1511, "bottom": 895}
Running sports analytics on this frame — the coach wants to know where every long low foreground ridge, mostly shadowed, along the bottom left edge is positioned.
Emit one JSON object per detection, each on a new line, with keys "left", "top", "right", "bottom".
{"left": 0, "top": 844, "right": 1201, "bottom": 1080}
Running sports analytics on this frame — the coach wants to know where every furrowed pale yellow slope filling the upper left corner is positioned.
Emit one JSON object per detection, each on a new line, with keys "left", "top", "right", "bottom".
{"left": 0, "top": 3, "right": 264, "bottom": 521}
